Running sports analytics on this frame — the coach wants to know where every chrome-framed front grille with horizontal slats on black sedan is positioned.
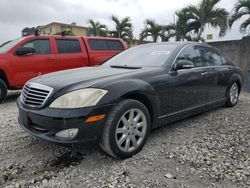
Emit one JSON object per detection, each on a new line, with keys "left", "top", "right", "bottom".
{"left": 21, "top": 82, "right": 53, "bottom": 108}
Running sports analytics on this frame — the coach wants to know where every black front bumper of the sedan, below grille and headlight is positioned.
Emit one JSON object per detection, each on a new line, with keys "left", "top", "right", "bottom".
{"left": 17, "top": 99, "right": 114, "bottom": 144}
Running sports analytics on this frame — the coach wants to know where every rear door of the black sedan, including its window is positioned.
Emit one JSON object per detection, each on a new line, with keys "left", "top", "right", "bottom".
{"left": 201, "top": 46, "right": 232, "bottom": 102}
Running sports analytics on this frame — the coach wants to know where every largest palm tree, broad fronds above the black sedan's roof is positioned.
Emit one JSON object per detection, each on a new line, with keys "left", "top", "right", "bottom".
{"left": 183, "top": 0, "right": 228, "bottom": 40}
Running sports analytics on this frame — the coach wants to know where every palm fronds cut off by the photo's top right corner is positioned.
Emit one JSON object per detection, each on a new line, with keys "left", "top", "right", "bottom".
{"left": 229, "top": 0, "right": 250, "bottom": 33}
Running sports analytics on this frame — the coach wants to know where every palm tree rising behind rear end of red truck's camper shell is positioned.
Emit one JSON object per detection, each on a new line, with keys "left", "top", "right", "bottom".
{"left": 110, "top": 15, "right": 133, "bottom": 41}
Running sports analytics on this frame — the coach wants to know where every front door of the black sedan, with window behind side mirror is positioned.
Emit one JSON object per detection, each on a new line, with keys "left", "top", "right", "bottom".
{"left": 160, "top": 45, "right": 209, "bottom": 115}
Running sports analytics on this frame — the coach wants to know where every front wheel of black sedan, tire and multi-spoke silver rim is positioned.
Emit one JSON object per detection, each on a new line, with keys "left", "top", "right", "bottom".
{"left": 100, "top": 99, "right": 151, "bottom": 159}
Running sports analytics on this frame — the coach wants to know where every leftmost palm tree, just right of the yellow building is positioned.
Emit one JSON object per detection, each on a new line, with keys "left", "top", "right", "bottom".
{"left": 88, "top": 19, "right": 108, "bottom": 37}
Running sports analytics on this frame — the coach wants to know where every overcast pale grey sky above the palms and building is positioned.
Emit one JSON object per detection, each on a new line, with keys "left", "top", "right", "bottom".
{"left": 0, "top": 0, "right": 246, "bottom": 44}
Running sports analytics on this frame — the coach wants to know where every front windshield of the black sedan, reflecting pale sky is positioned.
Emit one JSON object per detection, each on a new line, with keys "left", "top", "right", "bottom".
{"left": 103, "top": 43, "right": 177, "bottom": 67}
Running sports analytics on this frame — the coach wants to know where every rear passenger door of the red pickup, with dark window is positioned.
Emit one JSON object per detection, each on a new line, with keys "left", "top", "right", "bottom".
{"left": 52, "top": 37, "right": 89, "bottom": 71}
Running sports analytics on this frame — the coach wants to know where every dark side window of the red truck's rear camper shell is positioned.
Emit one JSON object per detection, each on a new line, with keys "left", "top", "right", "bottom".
{"left": 88, "top": 39, "right": 124, "bottom": 51}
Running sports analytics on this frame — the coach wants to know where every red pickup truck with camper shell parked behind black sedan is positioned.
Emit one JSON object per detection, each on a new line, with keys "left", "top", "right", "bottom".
{"left": 0, "top": 36, "right": 127, "bottom": 103}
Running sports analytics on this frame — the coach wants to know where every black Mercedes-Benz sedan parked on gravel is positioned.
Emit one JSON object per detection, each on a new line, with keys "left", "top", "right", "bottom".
{"left": 17, "top": 42, "right": 243, "bottom": 158}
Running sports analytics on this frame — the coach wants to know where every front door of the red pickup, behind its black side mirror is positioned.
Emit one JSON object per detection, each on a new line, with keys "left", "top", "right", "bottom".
{"left": 10, "top": 38, "right": 55, "bottom": 88}
